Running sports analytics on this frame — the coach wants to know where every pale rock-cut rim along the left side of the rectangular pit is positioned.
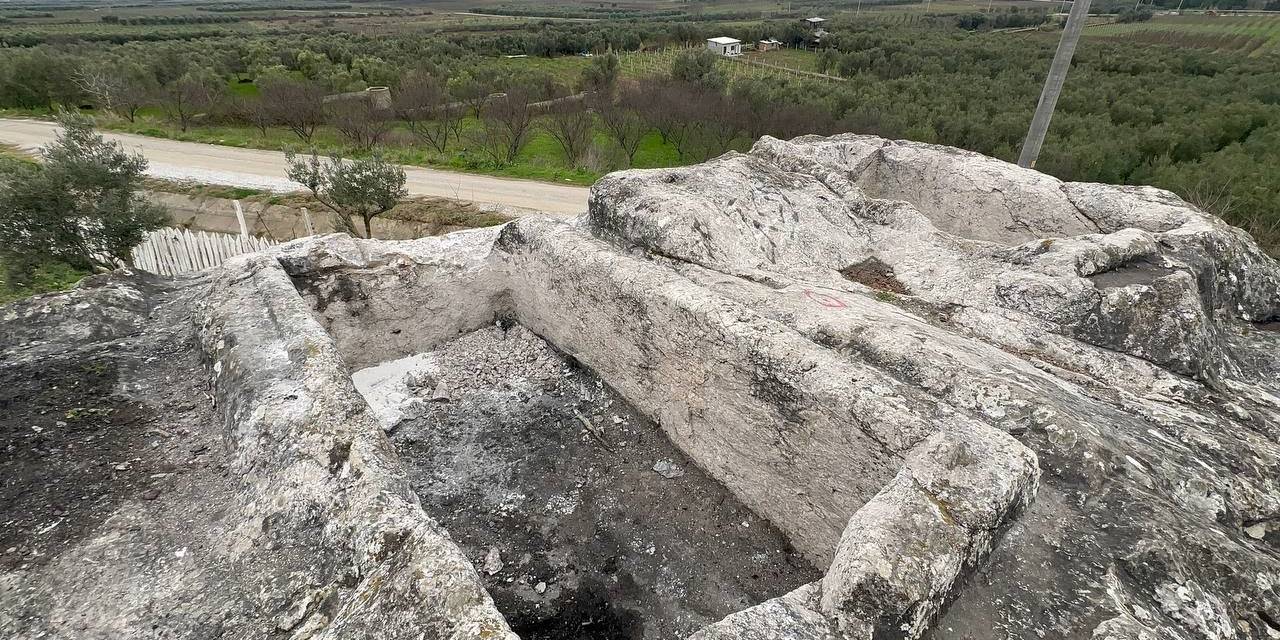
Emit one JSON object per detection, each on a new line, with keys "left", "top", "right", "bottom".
{"left": 195, "top": 255, "right": 516, "bottom": 639}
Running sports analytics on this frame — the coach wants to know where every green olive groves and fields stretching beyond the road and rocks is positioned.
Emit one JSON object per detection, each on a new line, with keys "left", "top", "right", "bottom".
{"left": 0, "top": 4, "right": 1280, "bottom": 251}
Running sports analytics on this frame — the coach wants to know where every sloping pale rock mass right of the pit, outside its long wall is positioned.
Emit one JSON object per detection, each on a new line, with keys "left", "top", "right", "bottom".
{"left": 579, "top": 136, "right": 1280, "bottom": 639}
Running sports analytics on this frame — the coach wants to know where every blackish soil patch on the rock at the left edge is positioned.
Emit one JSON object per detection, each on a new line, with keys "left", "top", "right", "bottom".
{"left": 0, "top": 351, "right": 161, "bottom": 568}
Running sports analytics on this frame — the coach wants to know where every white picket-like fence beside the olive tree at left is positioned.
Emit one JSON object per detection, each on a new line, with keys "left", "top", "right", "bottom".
{"left": 133, "top": 227, "right": 276, "bottom": 275}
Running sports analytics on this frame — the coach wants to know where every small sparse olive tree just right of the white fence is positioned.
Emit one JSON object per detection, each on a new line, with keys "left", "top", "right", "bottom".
{"left": 285, "top": 151, "right": 407, "bottom": 238}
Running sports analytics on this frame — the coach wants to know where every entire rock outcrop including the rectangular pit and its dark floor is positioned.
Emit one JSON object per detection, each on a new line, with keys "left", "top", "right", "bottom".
{"left": 0, "top": 136, "right": 1280, "bottom": 640}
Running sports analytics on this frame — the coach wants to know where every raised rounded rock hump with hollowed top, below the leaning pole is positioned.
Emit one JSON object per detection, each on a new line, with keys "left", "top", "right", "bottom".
{"left": 585, "top": 136, "right": 1280, "bottom": 381}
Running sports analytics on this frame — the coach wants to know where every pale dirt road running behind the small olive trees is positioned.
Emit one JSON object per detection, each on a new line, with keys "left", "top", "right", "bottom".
{"left": 0, "top": 118, "right": 588, "bottom": 218}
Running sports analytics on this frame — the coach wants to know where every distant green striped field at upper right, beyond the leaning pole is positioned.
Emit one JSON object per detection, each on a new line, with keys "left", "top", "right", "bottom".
{"left": 1084, "top": 15, "right": 1280, "bottom": 55}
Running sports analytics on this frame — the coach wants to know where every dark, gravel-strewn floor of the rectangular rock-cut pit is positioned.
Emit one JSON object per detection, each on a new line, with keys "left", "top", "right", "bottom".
{"left": 353, "top": 324, "right": 822, "bottom": 640}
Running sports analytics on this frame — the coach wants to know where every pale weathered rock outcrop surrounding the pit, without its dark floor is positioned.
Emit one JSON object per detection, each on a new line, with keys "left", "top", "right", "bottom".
{"left": 0, "top": 136, "right": 1280, "bottom": 640}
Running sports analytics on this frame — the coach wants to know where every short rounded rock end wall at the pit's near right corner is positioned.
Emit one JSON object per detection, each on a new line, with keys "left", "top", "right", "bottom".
{"left": 822, "top": 426, "right": 1039, "bottom": 637}
